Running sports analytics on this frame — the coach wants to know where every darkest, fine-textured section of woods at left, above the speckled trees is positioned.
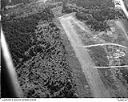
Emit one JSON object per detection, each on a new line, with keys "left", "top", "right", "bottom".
{"left": 2, "top": 8, "right": 54, "bottom": 65}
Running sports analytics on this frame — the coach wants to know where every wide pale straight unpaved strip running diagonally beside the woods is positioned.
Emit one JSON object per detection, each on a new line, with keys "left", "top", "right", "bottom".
{"left": 59, "top": 15, "right": 111, "bottom": 97}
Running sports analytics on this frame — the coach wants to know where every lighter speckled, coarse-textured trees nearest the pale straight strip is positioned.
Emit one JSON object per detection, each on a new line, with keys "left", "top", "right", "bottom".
{"left": 19, "top": 20, "right": 76, "bottom": 97}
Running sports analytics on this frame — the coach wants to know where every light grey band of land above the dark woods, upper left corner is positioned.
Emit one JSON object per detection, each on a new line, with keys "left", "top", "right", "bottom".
{"left": 1, "top": 2, "right": 48, "bottom": 21}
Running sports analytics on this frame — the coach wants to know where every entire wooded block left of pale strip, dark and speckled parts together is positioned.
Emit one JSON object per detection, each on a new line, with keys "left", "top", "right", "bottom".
{"left": 2, "top": 8, "right": 77, "bottom": 97}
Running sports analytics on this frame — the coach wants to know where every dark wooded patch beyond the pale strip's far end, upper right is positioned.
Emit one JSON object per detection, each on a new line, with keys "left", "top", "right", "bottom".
{"left": 62, "top": 4, "right": 125, "bottom": 31}
